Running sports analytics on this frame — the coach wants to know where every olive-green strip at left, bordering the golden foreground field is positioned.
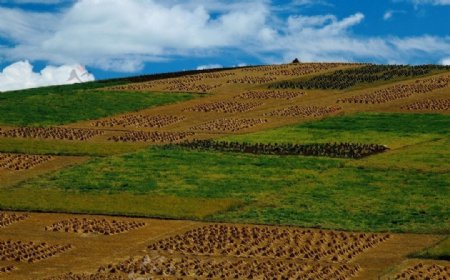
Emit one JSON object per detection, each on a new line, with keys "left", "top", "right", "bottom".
{"left": 0, "top": 188, "right": 241, "bottom": 219}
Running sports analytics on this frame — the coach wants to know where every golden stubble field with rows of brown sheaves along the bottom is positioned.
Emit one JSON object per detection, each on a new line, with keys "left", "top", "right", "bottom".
{"left": 0, "top": 212, "right": 449, "bottom": 279}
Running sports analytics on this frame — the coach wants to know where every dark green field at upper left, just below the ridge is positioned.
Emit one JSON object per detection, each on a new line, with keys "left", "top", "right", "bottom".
{"left": 0, "top": 83, "right": 196, "bottom": 126}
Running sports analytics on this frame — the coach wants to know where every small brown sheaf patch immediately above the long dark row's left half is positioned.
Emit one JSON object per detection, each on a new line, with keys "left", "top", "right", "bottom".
{"left": 191, "top": 119, "right": 267, "bottom": 131}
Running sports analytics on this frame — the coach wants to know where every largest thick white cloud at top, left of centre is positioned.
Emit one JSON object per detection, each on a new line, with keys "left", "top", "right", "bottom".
{"left": 0, "top": 0, "right": 271, "bottom": 72}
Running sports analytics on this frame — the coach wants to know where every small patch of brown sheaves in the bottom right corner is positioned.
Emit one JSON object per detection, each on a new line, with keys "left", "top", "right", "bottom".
{"left": 395, "top": 263, "right": 450, "bottom": 280}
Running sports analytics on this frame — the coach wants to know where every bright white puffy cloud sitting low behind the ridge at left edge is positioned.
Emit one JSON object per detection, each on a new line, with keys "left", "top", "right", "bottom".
{"left": 0, "top": 61, "right": 95, "bottom": 91}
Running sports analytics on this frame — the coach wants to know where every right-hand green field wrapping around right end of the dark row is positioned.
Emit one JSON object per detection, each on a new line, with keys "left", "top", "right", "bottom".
{"left": 223, "top": 113, "right": 450, "bottom": 172}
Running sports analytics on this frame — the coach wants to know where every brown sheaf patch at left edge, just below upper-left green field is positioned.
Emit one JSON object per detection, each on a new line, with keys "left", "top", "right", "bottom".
{"left": 0, "top": 127, "right": 104, "bottom": 141}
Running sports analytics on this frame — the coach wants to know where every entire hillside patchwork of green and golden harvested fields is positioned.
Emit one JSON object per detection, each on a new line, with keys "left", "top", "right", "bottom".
{"left": 0, "top": 63, "right": 450, "bottom": 279}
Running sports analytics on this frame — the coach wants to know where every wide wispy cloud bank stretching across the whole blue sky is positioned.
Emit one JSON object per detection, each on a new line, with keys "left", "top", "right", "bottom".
{"left": 0, "top": 0, "right": 450, "bottom": 72}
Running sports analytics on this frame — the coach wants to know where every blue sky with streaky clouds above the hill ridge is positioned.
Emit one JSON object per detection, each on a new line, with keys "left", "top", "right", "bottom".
{"left": 0, "top": 0, "right": 450, "bottom": 90}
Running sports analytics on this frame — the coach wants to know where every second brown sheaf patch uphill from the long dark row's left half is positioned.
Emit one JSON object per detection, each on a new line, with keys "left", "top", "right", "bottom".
{"left": 183, "top": 101, "right": 263, "bottom": 113}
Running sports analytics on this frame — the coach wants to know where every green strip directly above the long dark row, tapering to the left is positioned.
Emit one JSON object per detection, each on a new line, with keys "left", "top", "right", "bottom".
{"left": 226, "top": 113, "right": 450, "bottom": 142}
